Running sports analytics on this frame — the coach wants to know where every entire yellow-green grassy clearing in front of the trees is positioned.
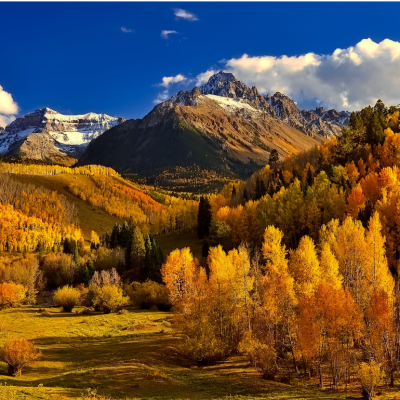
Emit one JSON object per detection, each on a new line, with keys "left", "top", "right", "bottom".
{"left": 0, "top": 306, "right": 400, "bottom": 400}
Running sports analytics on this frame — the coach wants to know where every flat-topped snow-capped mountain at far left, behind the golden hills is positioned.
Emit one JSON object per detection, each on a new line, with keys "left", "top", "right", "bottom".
{"left": 0, "top": 107, "right": 125, "bottom": 164}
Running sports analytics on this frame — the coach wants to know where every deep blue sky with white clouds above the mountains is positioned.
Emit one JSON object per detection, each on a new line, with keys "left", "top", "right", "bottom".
{"left": 0, "top": 2, "right": 400, "bottom": 123}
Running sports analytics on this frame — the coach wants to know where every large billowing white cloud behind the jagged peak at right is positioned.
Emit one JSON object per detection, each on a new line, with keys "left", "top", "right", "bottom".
{"left": 197, "top": 39, "right": 400, "bottom": 110}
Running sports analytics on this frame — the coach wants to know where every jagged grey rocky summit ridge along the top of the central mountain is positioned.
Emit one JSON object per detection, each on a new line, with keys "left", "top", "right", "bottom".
{"left": 199, "top": 71, "right": 350, "bottom": 138}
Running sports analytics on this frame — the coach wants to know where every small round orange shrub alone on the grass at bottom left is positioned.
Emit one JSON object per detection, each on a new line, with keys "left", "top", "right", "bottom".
{"left": 0, "top": 338, "right": 40, "bottom": 376}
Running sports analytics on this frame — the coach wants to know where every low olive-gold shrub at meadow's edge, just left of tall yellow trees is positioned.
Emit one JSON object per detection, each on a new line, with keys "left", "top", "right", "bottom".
{"left": 127, "top": 281, "right": 172, "bottom": 311}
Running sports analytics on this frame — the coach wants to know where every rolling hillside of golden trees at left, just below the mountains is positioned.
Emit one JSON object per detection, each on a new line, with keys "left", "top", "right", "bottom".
{"left": 0, "top": 163, "right": 197, "bottom": 240}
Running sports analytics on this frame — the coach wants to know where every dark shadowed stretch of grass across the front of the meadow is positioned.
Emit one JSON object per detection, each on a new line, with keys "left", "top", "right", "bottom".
{"left": 0, "top": 333, "right": 357, "bottom": 400}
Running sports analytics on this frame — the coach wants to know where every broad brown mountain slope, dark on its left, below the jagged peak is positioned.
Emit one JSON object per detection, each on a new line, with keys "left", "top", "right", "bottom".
{"left": 79, "top": 77, "right": 324, "bottom": 188}
